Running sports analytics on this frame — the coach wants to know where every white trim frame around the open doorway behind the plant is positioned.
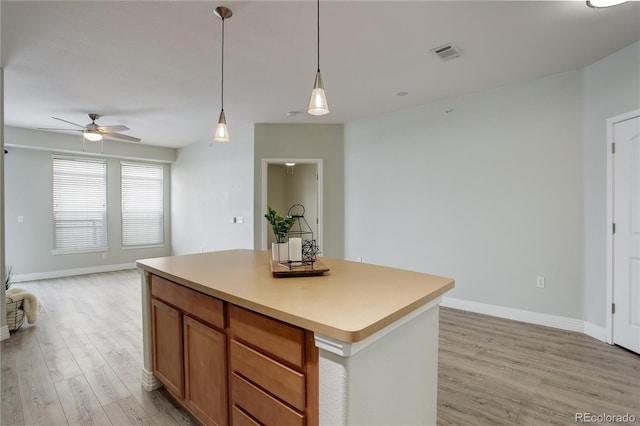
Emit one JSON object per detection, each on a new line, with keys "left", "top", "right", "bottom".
{"left": 260, "top": 158, "right": 324, "bottom": 256}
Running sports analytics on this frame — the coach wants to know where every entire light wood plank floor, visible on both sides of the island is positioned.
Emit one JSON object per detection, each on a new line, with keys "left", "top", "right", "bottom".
{"left": 0, "top": 270, "right": 640, "bottom": 426}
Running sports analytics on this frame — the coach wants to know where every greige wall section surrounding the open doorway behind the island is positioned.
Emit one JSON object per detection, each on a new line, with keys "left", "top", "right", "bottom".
{"left": 254, "top": 124, "right": 344, "bottom": 259}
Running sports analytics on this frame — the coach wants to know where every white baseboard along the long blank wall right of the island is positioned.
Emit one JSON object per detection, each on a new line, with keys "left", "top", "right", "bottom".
{"left": 440, "top": 296, "right": 584, "bottom": 334}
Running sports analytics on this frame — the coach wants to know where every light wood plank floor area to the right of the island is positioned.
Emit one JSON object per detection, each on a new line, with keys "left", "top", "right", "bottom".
{"left": 438, "top": 308, "right": 640, "bottom": 426}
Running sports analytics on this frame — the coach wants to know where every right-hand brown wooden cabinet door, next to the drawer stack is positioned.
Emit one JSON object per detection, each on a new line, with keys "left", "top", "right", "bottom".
{"left": 184, "top": 316, "right": 227, "bottom": 425}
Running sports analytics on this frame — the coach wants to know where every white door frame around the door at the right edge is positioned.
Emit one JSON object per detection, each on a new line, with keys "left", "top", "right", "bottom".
{"left": 605, "top": 109, "right": 640, "bottom": 345}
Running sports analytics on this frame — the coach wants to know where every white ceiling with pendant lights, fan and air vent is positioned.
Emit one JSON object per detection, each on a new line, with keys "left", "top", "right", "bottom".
{"left": 0, "top": 0, "right": 640, "bottom": 148}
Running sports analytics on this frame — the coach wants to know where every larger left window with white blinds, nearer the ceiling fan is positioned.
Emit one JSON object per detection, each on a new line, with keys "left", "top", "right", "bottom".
{"left": 53, "top": 156, "right": 108, "bottom": 253}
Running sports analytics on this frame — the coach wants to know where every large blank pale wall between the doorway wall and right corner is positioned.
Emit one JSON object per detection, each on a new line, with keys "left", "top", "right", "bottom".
{"left": 345, "top": 71, "right": 584, "bottom": 318}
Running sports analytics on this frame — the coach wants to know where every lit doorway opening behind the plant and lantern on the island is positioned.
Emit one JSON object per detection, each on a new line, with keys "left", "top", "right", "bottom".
{"left": 260, "top": 158, "right": 323, "bottom": 250}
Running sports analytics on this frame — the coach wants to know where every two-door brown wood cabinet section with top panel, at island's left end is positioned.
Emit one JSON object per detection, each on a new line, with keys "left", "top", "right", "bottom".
{"left": 151, "top": 276, "right": 228, "bottom": 425}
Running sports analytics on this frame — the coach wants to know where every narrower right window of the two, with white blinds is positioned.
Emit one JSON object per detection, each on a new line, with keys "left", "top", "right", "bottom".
{"left": 120, "top": 162, "right": 164, "bottom": 247}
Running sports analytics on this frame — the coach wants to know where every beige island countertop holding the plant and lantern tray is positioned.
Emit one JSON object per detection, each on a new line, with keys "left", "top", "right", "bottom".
{"left": 137, "top": 250, "right": 454, "bottom": 343}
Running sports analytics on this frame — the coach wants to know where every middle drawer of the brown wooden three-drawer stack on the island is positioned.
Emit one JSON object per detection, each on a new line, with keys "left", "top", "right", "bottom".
{"left": 230, "top": 340, "right": 305, "bottom": 411}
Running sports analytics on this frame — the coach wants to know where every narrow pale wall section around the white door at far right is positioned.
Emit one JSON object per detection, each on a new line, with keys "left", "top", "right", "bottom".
{"left": 583, "top": 42, "right": 640, "bottom": 327}
